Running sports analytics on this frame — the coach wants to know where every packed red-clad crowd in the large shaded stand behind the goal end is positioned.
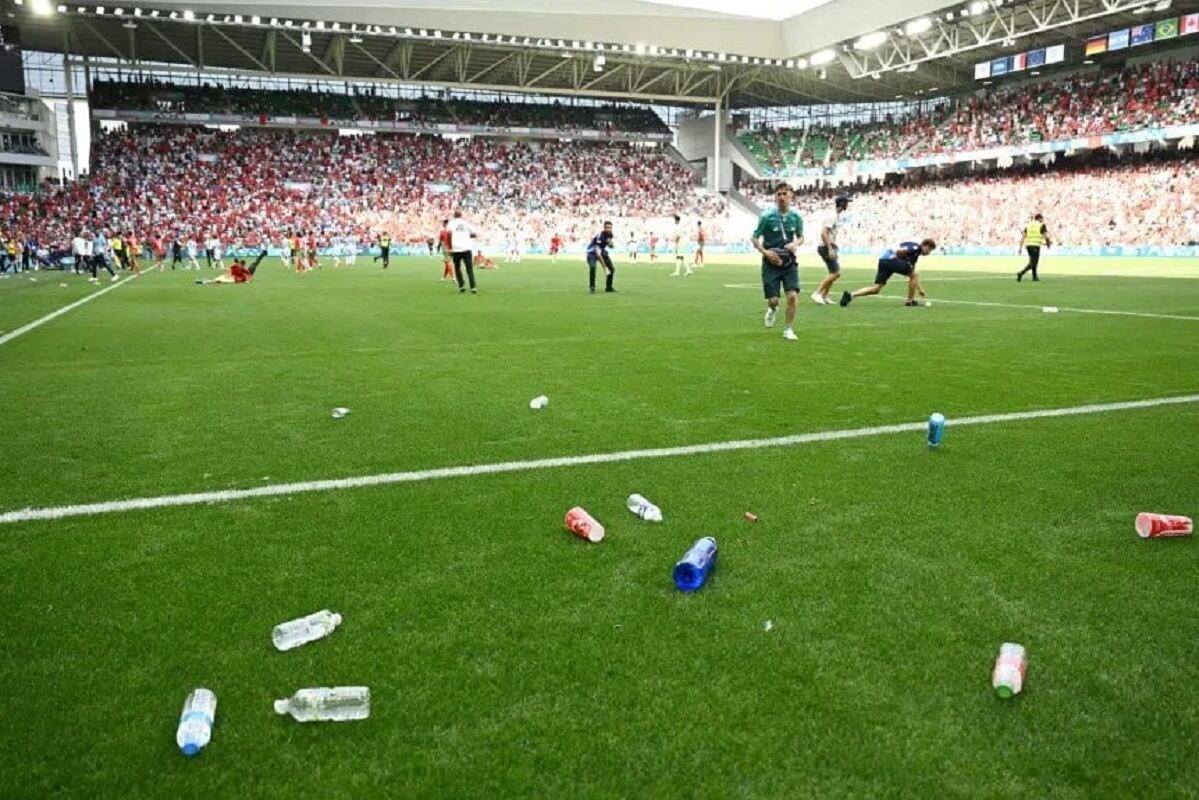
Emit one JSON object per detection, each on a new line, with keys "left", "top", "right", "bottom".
{"left": 0, "top": 125, "right": 725, "bottom": 260}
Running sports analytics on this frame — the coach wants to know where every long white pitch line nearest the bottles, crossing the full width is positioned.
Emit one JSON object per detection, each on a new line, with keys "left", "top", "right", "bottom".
{"left": 0, "top": 395, "right": 1199, "bottom": 524}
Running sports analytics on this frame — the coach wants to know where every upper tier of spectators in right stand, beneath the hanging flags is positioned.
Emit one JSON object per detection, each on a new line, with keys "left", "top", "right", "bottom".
{"left": 740, "top": 59, "right": 1199, "bottom": 175}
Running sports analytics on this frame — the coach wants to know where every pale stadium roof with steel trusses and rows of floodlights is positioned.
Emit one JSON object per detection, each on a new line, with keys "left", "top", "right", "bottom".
{"left": 17, "top": 0, "right": 1199, "bottom": 108}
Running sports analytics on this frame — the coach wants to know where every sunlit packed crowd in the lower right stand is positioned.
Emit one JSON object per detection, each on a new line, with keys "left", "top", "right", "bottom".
{"left": 741, "top": 149, "right": 1199, "bottom": 249}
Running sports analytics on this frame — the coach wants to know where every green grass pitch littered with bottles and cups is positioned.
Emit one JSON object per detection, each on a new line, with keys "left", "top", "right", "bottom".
{"left": 0, "top": 259, "right": 1199, "bottom": 798}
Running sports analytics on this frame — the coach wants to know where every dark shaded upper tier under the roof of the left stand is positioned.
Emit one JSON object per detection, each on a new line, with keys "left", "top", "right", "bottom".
{"left": 90, "top": 80, "right": 670, "bottom": 134}
